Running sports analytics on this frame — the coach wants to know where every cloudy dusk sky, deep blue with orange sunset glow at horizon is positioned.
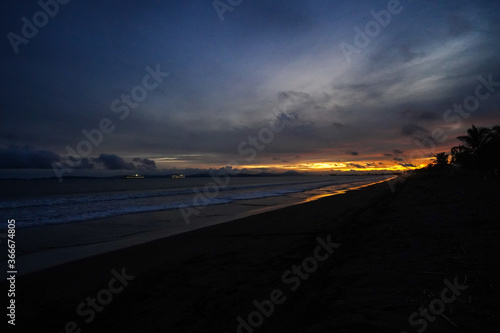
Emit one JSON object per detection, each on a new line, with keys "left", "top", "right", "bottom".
{"left": 0, "top": 0, "right": 500, "bottom": 176}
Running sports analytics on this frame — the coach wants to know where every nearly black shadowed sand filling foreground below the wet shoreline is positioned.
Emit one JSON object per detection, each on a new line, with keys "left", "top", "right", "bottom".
{"left": 6, "top": 177, "right": 500, "bottom": 332}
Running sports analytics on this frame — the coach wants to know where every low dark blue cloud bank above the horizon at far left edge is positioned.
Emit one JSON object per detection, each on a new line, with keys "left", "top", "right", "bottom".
{"left": 0, "top": 147, "right": 60, "bottom": 169}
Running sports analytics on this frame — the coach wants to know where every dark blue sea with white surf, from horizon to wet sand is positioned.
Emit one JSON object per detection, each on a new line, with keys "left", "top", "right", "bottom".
{"left": 0, "top": 176, "right": 386, "bottom": 229}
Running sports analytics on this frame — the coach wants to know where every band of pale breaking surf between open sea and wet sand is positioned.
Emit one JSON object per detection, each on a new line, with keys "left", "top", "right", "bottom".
{"left": 0, "top": 179, "right": 382, "bottom": 227}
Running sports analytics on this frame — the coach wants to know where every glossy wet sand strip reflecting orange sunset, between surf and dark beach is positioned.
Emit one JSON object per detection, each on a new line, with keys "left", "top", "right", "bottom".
{"left": 8, "top": 177, "right": 394, "bottom": 276}
